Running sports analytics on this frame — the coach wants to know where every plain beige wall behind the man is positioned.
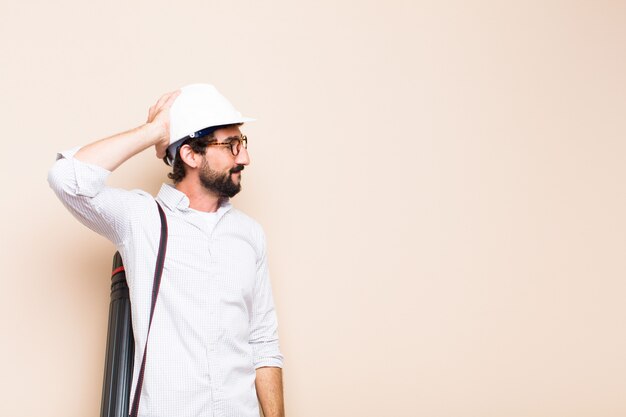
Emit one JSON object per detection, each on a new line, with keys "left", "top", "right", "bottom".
{"left": 0, "top": 0, "right": 626, "bottom": 417}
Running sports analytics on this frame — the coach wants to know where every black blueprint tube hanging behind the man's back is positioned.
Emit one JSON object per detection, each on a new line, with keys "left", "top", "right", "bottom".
{"left": 100, "top": 252, "right": 135, "bottom": 417}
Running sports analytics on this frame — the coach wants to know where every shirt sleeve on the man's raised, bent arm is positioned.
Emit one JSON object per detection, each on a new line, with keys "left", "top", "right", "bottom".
{"left": 48, "top": 148, "right": 143, "bottom": 246}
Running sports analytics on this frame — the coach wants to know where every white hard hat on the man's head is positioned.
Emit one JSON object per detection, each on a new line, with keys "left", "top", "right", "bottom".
{"left": 166, "top": 84, "right": 254, "bottom": 165}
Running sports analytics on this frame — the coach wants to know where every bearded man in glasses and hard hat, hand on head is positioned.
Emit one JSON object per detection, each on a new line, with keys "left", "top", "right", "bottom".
{"left": 48, "top": 84, "right": 284, "bottom": 417}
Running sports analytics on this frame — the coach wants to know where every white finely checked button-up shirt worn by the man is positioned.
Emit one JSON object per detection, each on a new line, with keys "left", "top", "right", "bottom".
{"left": 48, "top": 148, "right": 283, "bottom": 417}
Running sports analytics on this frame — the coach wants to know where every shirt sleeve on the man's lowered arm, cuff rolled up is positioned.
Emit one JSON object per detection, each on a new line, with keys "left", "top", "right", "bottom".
{"left": 250, "top": 228, "right": 283, "bottom": 369}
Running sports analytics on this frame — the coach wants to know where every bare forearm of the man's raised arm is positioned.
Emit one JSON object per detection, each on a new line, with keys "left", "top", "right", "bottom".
{"left": 74, "top": 123, "right": 167, "bottom": 171}
